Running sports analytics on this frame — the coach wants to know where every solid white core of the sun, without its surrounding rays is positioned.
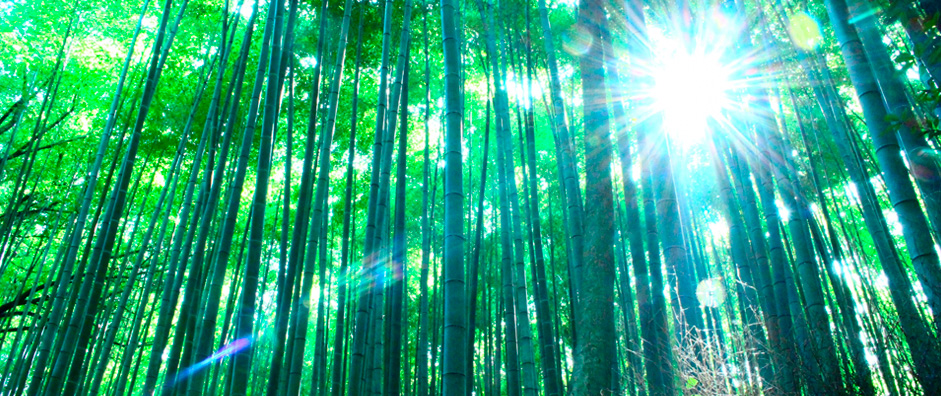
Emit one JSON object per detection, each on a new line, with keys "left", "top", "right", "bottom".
{"left": 652, "top": 48, "right": 730, "bottom": 145}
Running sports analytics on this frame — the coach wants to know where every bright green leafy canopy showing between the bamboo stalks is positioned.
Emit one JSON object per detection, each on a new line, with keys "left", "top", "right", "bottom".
{"left": 0, "top": 0, "right": 941, "bottom": 393}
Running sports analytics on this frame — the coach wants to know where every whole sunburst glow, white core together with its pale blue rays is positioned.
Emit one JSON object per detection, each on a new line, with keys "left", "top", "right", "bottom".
{"left": 618, "top": 7, "right": 772, "bottom": 156}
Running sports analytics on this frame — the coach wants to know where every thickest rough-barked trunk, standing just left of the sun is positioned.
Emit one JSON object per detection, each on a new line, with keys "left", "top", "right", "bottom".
{"left": 570, "top": 0, "right": 617, "bottom": 395}
